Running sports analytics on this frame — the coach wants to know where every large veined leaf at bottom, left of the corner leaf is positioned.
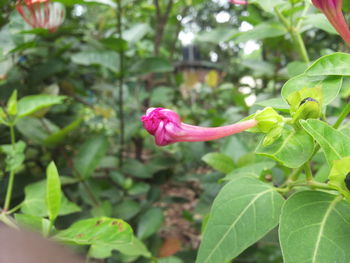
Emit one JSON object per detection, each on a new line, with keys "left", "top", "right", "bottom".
{"left": 196, "top": 177, "right": 283, "bottom": 263}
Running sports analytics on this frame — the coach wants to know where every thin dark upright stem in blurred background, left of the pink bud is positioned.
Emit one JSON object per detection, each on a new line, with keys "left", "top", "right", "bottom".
{"left": 117, "top": 0, "right": 125, "bottom": 167}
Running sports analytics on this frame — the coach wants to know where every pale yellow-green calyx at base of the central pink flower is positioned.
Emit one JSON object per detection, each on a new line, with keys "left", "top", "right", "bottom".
{"left": 254, "top": 107, "right": 283, "bottom": 133}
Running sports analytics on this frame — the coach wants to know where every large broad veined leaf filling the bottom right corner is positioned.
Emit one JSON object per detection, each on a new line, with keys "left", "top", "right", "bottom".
{"left": 279, "top": 191, "right": 350, "bottom": 263}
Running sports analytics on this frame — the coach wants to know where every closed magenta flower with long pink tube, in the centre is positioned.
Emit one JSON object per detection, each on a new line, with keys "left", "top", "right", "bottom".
{"left": 141, "top": 108, "right": 257, "bottom": 146}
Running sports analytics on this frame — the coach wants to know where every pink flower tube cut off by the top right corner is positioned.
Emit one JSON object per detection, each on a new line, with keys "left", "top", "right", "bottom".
{"left": 312, "top": 0, "right": 350, "bottom": 45}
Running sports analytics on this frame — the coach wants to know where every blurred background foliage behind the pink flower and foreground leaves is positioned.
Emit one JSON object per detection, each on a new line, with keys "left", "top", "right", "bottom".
{"left": 0, "top": 0, "right": 349, "bottom": 263}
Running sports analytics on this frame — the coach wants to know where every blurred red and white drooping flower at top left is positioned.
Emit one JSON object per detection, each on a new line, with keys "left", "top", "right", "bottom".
{"left": 16, "top": 0, "right": 65, "bottom": 32}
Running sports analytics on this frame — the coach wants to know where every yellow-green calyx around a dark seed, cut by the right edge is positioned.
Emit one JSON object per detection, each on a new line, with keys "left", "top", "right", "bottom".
{"left": 328, "top": 156, "right": 350, "bottom": 202}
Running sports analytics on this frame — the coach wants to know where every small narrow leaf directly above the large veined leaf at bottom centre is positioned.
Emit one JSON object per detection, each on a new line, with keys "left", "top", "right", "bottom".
{"left": 222, "top": 162, "right": 276, "bottom": 180}
